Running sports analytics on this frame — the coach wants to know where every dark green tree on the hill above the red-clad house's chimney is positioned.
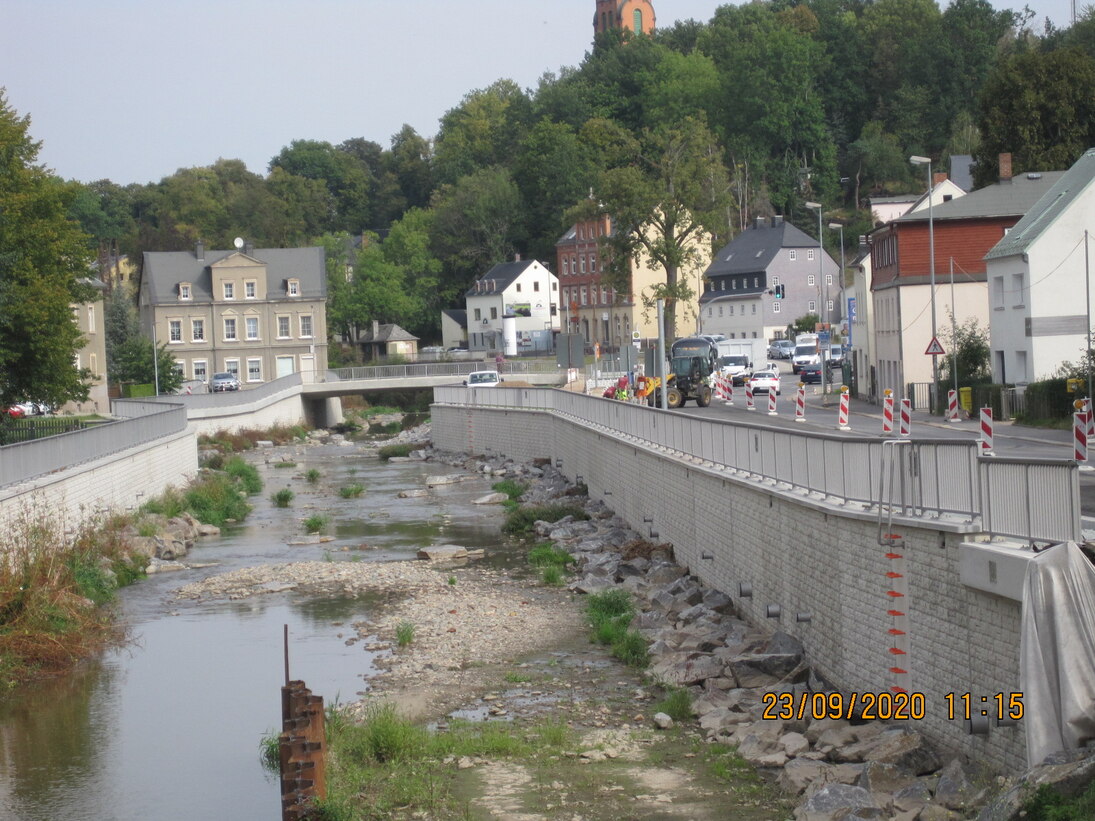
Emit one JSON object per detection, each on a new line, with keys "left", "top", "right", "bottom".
{"left": 973, "top": 48, "right": 1095, "bottom": 186}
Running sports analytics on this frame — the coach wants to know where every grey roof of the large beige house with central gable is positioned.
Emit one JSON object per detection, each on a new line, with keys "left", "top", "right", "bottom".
{"left": 142, "top": 246, "right": 327, "bottom": 304}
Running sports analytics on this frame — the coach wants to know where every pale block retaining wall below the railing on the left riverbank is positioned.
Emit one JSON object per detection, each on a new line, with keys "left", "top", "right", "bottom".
{"left": 0, "top": 430, "right": 198, "bottom": 536}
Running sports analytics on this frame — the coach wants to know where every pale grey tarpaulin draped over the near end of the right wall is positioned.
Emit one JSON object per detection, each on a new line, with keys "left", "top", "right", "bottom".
{"left": 1019, "top": 542, "right": 1095, "bottom": 766}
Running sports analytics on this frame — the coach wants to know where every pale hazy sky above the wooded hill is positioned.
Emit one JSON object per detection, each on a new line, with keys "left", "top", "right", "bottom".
{"left": 0, "top": 0, "right": 1087, "bottom": 185}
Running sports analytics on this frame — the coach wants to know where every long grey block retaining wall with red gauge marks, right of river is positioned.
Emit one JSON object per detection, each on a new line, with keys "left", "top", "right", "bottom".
{"left": 431, "top": 405, "right": 1026, "bottom": 771}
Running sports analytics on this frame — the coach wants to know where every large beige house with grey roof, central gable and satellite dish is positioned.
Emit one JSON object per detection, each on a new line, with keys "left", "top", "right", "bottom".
{"left": 138, "top": 242, "right": 327, "bottom": 389}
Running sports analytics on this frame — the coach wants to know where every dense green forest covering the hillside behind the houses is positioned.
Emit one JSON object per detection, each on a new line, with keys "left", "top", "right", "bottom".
{"left": 4, "top": 0, "right": 1095, "bottom": 407}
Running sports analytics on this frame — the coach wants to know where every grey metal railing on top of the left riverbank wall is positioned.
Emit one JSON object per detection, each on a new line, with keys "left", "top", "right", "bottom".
{"left": 0, "top": 400, "right": 186, "bottom": 487}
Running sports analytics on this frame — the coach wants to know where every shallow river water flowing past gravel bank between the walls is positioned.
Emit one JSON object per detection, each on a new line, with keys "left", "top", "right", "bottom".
{"left": 0, "top": 444, "right": 506, "bottom": 821}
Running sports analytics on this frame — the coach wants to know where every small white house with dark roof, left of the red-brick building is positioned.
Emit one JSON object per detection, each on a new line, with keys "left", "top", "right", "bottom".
{"left": 464, "top": 258, "right": 560, "bottom": 351}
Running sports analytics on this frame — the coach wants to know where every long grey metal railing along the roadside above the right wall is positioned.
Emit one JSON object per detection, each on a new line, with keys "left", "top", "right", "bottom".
{"left": 434, "top": 386, "right": 1080, "bottom": 542}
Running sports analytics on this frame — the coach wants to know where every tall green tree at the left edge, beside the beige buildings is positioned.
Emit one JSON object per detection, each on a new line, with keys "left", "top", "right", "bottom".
{"left": 0, "top": 89, "right": 92, "bottom": 405}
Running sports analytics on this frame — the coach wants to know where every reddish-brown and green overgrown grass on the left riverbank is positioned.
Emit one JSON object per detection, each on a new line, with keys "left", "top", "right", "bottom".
{"left": 0, "top": 509, "right": 147, "bottom": 692}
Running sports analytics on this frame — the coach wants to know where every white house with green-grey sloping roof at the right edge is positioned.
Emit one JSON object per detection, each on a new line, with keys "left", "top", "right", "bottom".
{"left": 984, "top": 148, "right": 1095, "bottom": 384}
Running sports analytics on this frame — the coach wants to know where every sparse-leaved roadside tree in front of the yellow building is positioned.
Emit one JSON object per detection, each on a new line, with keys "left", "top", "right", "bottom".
{"left": 579, "top": 118, "right": 729, "bottom": 340}
